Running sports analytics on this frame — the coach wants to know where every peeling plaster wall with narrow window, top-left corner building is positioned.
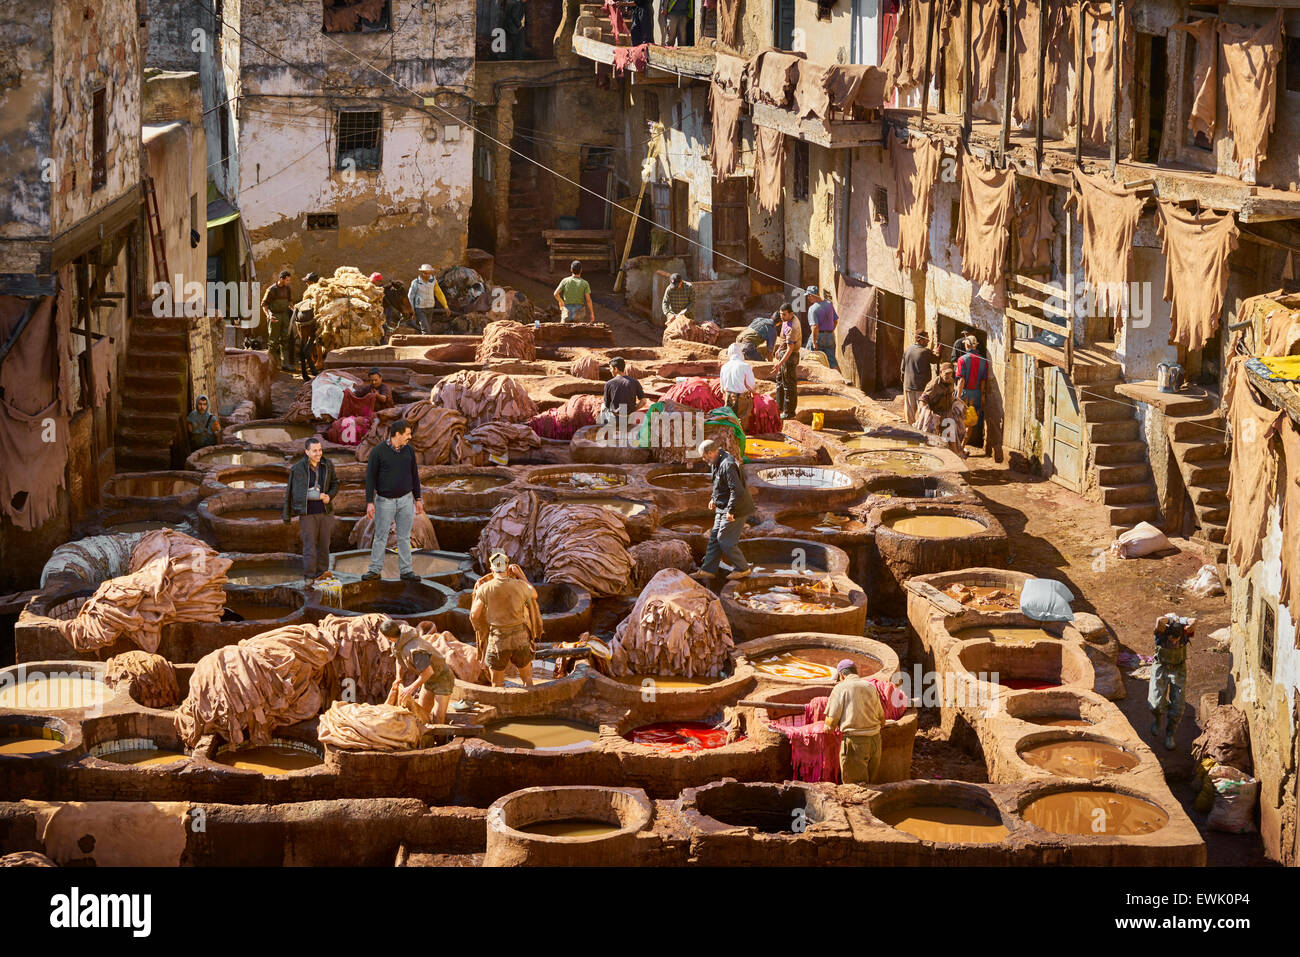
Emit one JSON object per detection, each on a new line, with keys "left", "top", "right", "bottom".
{"left": 51, "top": 0, "right": 143, "bottom": 235}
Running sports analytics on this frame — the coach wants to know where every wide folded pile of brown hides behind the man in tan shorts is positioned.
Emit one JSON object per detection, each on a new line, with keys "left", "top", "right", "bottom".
{"left": 472, "top": 492, "right": 632, "bottom": 598}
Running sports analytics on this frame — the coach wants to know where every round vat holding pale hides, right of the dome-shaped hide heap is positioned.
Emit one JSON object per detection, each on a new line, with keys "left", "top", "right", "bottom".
{"left": 722, "top": 575, "right": 867, "bottom": 640}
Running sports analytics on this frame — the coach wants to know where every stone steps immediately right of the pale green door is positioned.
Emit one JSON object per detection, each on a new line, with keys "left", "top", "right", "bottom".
{"left": 1079, "top": 378, "right": 1160, "bottom": 533}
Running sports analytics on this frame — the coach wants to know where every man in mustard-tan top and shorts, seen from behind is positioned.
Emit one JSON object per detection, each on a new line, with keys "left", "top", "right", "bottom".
{"left": 469, "top": 551, "right": 542, "bottom": 688}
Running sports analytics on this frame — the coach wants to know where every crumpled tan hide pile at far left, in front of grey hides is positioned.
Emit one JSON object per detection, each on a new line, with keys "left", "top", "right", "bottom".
{"left": 57, "top": 528, "right": 230, "bottom": 653}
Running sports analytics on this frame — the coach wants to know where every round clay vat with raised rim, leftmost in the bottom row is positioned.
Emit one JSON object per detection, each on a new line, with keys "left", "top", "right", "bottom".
{"left": 484, "top": 787, "right": 653, "bottom": 867}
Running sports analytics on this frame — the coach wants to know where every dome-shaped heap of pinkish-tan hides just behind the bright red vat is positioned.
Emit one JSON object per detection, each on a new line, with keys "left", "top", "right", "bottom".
{"left": 610, "top": 568, "right": 733, "bottom": 677}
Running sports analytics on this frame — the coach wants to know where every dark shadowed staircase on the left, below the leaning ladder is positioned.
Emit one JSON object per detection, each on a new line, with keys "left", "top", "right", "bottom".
{"left": 114, "top": 312, "right": 190, "bottom": 472}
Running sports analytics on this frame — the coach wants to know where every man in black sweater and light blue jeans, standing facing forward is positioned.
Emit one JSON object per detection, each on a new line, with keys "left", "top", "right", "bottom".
{"left": 361, "top": 419, "right": 424, "bottom": 581}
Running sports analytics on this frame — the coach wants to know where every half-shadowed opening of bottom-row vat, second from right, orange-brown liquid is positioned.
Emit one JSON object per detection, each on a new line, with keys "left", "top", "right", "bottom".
{"left": 871, "top": 783, "right": 1010, "bottom": 844}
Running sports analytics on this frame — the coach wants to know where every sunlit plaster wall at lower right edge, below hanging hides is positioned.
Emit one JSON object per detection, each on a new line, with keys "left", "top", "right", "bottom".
{"left": 1231, "top": 507, "right": 1300, "bottom": 865}
